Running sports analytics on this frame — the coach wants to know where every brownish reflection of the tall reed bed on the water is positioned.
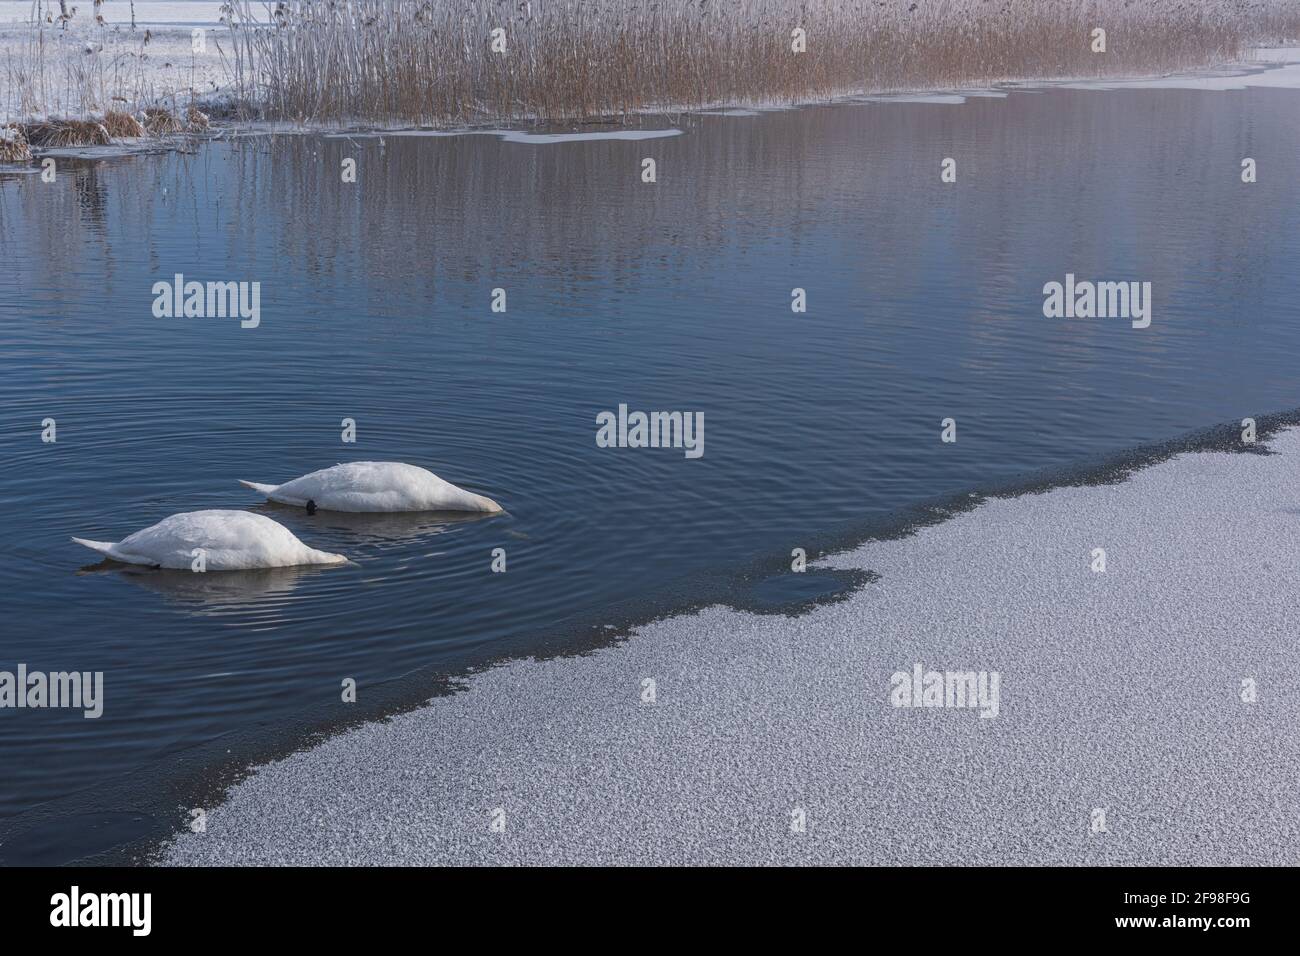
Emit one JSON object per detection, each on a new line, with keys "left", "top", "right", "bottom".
{"left": 213, "top": 91, "right": 1296, "bottom": 335}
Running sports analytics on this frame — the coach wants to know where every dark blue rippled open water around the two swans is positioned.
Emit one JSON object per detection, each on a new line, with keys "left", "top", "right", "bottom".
{"left": 0, "top": 80, "right": 1300, "bottom": 862}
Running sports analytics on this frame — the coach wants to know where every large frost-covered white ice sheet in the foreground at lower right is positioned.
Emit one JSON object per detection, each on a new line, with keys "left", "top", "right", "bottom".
{"left": 164, "top": 428, "right": 1300, "bottom": 865}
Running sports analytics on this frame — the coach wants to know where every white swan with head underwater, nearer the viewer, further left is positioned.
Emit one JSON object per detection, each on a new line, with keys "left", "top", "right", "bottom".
{"left": 73, "top": 511, "right": 347, "bottom": 571}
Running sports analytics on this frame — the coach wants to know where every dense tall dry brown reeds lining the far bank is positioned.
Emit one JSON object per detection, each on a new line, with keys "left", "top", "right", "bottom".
{"left": 218, "top": 0, "right": 1300, "bottom": 124}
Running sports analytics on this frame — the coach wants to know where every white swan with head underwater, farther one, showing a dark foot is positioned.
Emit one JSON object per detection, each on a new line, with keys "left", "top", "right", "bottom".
{"left": 239, "top": 462, "right": 502, "bottom": 512}
